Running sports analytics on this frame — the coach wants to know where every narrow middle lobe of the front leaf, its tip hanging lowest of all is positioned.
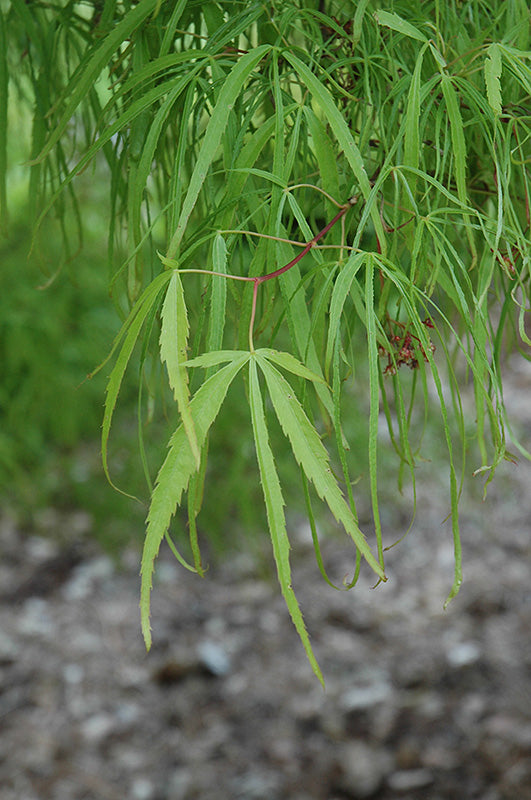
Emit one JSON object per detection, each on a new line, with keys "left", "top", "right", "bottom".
{"left": 249, "top": 357, "right": 324, "bottom": 686}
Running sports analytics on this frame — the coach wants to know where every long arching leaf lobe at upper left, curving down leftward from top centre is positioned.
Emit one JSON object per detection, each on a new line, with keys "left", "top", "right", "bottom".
{"left": 167, "top": 44, "right": 271, "bottom": 258}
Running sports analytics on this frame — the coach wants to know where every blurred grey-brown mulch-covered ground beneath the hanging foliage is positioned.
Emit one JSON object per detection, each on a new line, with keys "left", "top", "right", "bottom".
{"left": 0, "top": 360, "right": 531, "bottom": 800}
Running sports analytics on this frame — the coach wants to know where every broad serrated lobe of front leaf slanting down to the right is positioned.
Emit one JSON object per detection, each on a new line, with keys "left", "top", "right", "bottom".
{"left": 256, "top": 355, "right": 386, "bottom": 580}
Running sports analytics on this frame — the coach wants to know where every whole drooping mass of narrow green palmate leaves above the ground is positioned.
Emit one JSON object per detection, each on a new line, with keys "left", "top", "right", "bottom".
{"left": 0, "top": 0, "right": 531, "bottom": 674}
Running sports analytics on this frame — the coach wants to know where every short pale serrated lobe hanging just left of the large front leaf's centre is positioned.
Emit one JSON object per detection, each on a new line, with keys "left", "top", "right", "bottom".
{"left": 160, "top": 270, "right": 201, "bottom": 469}
